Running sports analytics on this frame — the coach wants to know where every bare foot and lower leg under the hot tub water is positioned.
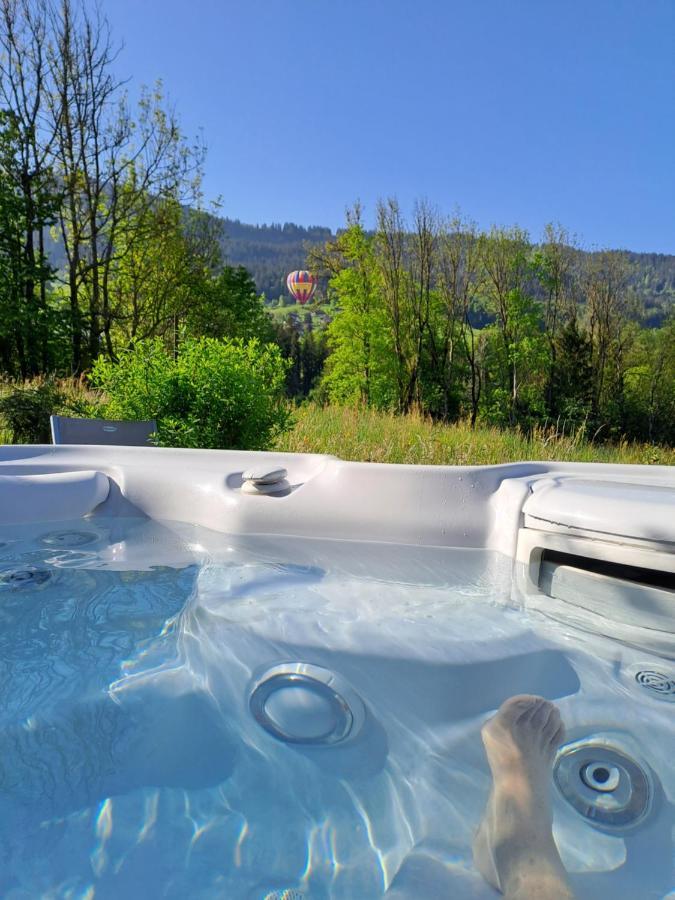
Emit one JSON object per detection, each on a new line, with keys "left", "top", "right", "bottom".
{"left": 473, "top": 694, "right": 573, "bottom": 900}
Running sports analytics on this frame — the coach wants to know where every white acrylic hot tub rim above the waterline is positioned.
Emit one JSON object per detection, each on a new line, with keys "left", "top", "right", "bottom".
{"left": 0, "top": 445, "right": 675, "bottom": 656}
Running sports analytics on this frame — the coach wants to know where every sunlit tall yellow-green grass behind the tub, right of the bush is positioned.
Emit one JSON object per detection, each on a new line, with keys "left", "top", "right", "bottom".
{"left": 274, "top": 404, "right": 675, "bottom": 465}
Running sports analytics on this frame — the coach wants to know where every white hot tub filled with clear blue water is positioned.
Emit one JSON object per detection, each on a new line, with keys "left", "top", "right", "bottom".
{"left": 0, "top": 446, "right": 675, "bottom": 900}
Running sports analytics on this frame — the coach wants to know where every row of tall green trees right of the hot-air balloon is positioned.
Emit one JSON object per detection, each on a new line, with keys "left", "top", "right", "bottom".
{"left": 314, "top": 212, "right": 675, "bottom": 443}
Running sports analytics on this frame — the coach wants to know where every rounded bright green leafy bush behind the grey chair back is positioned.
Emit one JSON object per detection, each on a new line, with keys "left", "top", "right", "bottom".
{"left": 92, "top": 338, "right": 289, "bottom": 450}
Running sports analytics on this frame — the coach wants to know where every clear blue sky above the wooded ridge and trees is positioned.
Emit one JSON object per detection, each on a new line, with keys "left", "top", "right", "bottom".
{"left": 102, "top": 0, "right": 675, "bottom": 252}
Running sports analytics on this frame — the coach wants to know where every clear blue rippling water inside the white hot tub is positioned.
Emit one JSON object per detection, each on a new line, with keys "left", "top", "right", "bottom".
{"left": 0, "top": 519, "right": 675, "bottom": 900}
